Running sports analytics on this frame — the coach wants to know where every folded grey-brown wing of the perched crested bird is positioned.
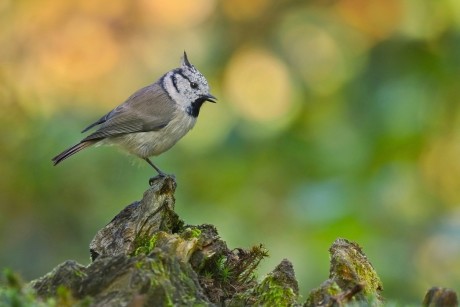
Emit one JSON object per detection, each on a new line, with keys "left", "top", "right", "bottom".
{"left": 83, "top": 83, "right": 176, "bottom": 141}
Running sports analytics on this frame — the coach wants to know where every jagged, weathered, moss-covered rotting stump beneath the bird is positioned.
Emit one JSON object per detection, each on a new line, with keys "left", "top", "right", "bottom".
{"left": 0, "top": 177, "right": 458, "bottom": 306}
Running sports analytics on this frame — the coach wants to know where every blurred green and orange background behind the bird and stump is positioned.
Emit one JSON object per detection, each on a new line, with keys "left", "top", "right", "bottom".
{"left": 0, "top": 0, "right": 460, "bottom": 303}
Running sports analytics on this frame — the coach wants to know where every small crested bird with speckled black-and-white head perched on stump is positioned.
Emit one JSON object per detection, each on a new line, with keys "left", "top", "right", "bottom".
{"left": 52, "top": 51, "right": 217, "bottom": 183}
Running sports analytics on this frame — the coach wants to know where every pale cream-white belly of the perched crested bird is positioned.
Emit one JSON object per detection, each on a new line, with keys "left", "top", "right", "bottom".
{"left": 110, "top": 116, "right": 196, "bottom": 158}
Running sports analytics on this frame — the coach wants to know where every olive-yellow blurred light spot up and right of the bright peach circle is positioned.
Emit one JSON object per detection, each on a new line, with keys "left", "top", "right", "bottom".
{"left": 279, "top": 11, "right": 358, "bottom": 96}
